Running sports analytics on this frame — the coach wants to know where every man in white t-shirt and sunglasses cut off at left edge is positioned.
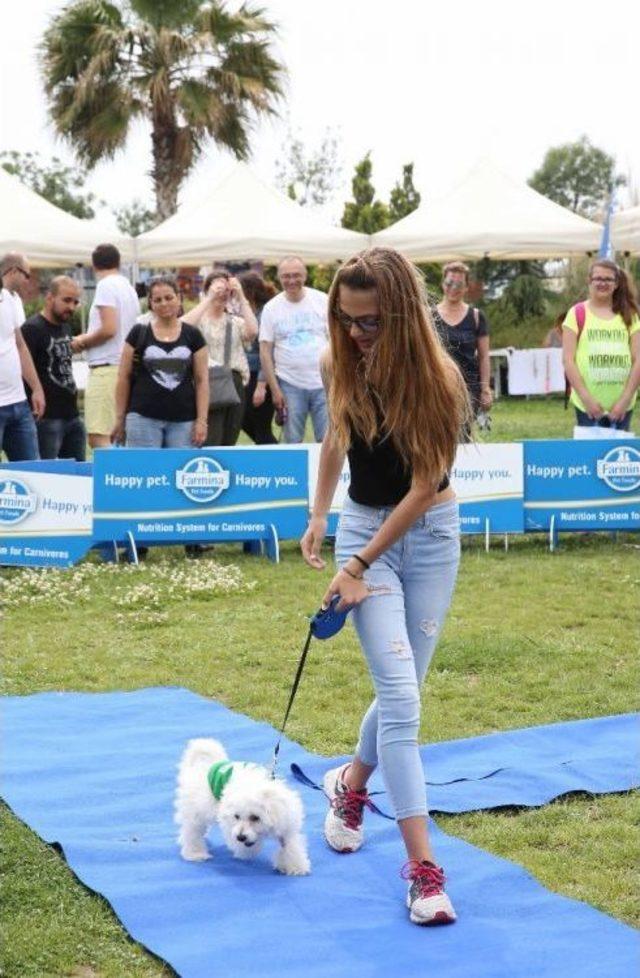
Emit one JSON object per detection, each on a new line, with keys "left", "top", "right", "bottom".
{"left": 0, "top": 252, "right": 45, "bottom": 462}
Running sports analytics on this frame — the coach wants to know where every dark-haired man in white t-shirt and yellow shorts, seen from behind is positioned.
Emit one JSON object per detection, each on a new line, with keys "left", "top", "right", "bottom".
{"left": 71, "top": 244, "right": 140, "bottom": 448}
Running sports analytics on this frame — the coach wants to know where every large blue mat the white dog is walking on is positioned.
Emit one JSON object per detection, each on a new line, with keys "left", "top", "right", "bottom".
{"left": 3, "top": 689, "right": 640, "bottom": 978}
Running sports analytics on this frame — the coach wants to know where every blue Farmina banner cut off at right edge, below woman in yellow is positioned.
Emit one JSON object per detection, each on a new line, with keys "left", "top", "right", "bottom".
{"left": 524, "top": 437, "right": 640, "bottom": 531}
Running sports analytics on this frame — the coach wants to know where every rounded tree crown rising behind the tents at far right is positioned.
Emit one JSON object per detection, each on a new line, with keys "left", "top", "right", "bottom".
{"left": 529, "top": 136, "right": 626, "bottom": 218}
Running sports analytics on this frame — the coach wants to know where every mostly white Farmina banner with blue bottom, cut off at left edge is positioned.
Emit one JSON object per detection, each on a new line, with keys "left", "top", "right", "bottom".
{"left": 0, "top": 459, "right": 93, "bottom": 567}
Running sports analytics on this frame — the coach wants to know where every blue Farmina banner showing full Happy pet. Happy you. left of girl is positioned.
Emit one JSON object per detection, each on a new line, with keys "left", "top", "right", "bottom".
{"left": 93, "top": 447, "right": 308, "bottom": 544}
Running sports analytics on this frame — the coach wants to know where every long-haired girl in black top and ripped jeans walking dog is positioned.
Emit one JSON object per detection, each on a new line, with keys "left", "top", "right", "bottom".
{"left": 301, "top": 248, "right": 469, "bottom": 924}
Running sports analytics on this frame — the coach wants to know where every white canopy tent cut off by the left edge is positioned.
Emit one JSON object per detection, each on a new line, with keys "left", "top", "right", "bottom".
{"left": 0, "top": 167, "right": 132, "bottom": 268}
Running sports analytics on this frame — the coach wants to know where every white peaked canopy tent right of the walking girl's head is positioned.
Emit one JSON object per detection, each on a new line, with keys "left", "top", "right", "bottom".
{"left": 372, "top": 159, "right": 602, "bottom": 262}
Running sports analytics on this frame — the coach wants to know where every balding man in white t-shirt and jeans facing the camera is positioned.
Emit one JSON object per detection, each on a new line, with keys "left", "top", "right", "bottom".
{"left": 260, "top": 257, "right": 329, "bottom": 443}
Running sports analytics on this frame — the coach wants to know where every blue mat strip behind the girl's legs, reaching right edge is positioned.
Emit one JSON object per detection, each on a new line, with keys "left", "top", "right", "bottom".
{"left": 294, "top": 713, "right": 640, "bottom": 814}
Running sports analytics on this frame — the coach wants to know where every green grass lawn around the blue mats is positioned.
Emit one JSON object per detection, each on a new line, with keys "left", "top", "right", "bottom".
{"left": 0, "top": 399, "right": 640, "bottom": 978}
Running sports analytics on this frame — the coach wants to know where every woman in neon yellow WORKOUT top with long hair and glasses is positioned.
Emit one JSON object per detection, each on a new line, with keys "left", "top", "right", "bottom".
{"left": 562, "top": 258, "right": 640, "bottom": 431}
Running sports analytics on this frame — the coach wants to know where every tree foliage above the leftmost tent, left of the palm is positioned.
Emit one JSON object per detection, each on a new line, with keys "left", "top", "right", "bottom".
{"left": 0, "top": 149, "right": 102, "bottom": 218}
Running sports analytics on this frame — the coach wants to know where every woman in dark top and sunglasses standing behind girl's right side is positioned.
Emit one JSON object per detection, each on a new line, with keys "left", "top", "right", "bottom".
{"left": 434, "top": 261, "right": 493, "bottom": 441}
